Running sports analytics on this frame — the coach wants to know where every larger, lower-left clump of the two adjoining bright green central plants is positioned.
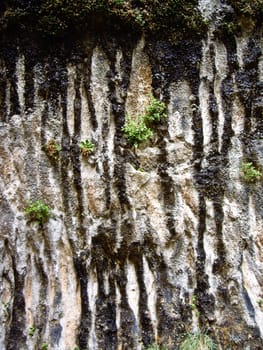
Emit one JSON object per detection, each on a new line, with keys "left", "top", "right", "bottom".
{"left": 123, "top": 116, "right": 153, "bottom": 147}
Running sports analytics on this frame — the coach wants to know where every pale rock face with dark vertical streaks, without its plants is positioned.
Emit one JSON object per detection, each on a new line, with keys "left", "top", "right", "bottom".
{"left": 0, "top": 1, "right": 263, "bottom": 350}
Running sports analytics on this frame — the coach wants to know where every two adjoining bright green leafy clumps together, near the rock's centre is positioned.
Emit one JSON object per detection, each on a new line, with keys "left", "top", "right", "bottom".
{"left": 123, "top": 97, "right": 167, "bottom": 147}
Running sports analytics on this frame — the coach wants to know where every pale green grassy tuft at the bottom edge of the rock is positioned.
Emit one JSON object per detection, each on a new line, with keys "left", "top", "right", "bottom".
{"left": 179, "top": 331, "right": 217, "bottom": 350}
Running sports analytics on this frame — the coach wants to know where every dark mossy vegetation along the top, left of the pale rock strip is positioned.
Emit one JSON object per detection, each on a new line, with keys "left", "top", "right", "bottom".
{"left": 0, "top": 0, "right": 206, "bottom": 38}
